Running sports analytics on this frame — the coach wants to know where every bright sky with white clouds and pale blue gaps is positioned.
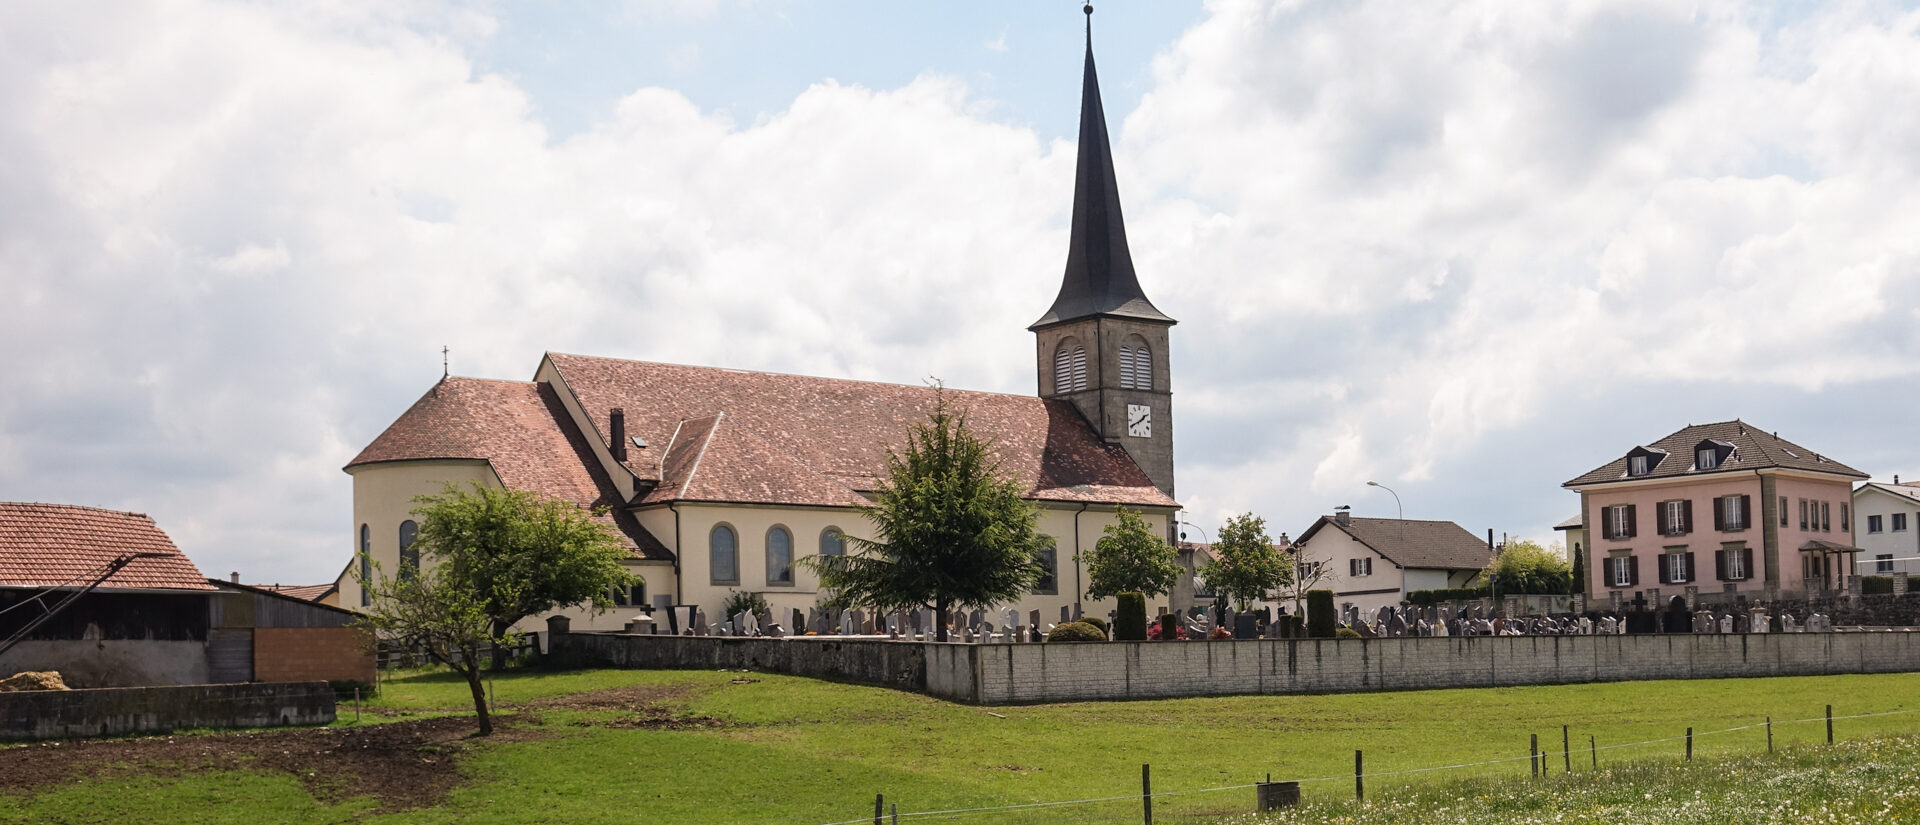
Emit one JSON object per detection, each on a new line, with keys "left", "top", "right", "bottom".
{"left": 0, "top": 0, "right": 1920, "bottom": 583}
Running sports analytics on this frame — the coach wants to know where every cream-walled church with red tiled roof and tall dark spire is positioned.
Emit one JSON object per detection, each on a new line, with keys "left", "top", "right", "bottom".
{"left": 338, "top": 20, "right": 1190, "bottom": 629}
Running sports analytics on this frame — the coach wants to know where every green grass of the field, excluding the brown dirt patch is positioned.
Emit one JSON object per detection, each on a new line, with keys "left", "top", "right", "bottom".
{"left": 0, "top": 672, "right": 1920, "bottom": 825}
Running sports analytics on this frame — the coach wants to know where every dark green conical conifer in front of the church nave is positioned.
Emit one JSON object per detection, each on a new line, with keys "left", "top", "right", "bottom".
{"left": 801, "top": 397, "right": 1054, "bottom": 641}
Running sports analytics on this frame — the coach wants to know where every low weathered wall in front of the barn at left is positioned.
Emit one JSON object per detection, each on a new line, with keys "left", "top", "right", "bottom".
{"left": 0, "top": 681, "right": 334, "bottom": 743}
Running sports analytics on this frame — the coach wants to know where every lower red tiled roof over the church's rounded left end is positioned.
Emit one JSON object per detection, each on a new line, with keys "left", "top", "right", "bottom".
{"left": 348, "top": 378, "right": 672, "bottom": 558}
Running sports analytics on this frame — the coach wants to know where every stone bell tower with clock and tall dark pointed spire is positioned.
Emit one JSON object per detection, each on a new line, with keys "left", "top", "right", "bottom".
{"left": 1029, "top": 6, "right": 1175, "bottom": 497}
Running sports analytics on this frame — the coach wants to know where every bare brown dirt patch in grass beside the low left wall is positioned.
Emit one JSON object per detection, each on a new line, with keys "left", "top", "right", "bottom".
{"left": 0, "top": 716, "right": 540, "bottom": 810}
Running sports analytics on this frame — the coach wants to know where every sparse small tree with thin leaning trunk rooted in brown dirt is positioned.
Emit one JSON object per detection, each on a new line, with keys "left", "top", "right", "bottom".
{"left": 353, "top": 566, "right": 518, "bottom": 737}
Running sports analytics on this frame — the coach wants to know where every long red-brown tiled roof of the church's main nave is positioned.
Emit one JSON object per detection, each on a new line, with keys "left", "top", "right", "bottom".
{"left": 547, "top": 353, "right": 1179, "bottom": 507}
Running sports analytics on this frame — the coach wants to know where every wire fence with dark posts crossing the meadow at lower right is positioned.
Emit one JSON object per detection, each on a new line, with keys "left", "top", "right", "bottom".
{"left": 822, "top": 706, "right": 1920, "bottom": 825}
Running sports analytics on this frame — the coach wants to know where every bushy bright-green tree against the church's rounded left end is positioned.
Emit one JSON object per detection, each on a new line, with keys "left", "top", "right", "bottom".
{"left": 413, "top": 483, "right": 639, "bottom": 670}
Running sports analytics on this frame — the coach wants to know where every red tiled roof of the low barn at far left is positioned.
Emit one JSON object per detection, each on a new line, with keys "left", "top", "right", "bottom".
{"left": 0, "top": 503, "right": 213, "bottom": 591}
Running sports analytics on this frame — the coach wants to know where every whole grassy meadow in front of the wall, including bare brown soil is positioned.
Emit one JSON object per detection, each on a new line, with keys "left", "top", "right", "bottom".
{"left": 0, "top": 670, "right": 1920, "bottom": 825}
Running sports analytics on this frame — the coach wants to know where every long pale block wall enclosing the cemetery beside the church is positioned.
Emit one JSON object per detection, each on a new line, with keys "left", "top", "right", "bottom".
{"left": 551, "top": 633, "right": 1920, "bottom": 704}
